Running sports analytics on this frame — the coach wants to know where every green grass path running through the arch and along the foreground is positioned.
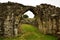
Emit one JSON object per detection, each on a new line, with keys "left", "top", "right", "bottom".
{"left": 0, "top": 24, "right": 57, "bottom": 40}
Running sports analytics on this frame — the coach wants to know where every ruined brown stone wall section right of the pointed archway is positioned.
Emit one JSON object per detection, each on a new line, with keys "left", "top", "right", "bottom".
{"left": 36, "top": 4, "right": 60, "bottom": 35}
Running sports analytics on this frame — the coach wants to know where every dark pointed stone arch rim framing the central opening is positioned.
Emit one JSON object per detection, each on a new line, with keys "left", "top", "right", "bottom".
{"left": 18, "top": 7, "right": 38, "bottom": 32}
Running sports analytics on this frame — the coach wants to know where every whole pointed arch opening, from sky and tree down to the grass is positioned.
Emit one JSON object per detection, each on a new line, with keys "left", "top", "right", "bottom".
{"left": 20, "top": 10, "right": 37, "bottom": 37}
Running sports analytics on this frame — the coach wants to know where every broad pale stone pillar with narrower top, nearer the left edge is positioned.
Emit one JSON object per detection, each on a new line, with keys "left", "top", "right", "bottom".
{"left": 4, "top": 15, "right": 13, "bottom": 37}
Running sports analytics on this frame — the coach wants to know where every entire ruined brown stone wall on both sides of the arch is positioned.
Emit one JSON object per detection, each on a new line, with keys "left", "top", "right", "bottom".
{"left": 0, "top": 2, "right": 60, "bottom": 37}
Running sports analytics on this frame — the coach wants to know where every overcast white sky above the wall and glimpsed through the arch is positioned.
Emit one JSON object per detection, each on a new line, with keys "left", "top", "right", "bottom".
{"left": 0, "top": 0, "right": 60, "bottom": 17}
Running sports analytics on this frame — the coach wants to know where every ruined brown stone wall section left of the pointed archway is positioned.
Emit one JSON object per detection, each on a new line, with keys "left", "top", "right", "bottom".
{"left": 0, "top": 2, "right": 31, "bottom": 37}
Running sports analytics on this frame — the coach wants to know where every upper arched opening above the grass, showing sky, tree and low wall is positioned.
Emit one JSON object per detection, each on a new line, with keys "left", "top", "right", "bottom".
{"left": 21, "top": 10, "right": 35, "bottom": 25}
